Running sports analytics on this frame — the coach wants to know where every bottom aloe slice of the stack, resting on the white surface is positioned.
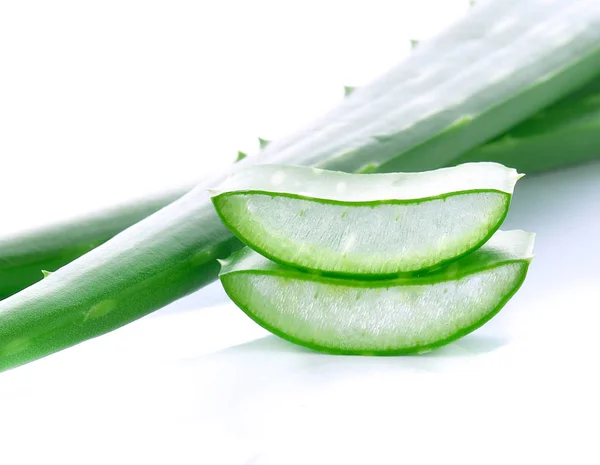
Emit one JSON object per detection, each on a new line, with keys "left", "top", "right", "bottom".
{"left": 220, "top": 231, "right": 534, "bottom": 355}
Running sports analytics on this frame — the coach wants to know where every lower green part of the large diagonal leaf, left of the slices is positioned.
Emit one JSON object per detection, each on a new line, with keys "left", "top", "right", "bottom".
{"left": 0, "top": 194, "right": 241, "bottom": 371}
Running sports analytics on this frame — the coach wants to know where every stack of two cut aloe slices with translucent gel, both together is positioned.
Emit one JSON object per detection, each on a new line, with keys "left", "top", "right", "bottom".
{"left": 210, "top": 162, "right": 534, "bottom": 354}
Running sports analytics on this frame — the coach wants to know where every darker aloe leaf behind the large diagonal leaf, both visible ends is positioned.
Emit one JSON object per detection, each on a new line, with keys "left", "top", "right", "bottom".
{"left": 0, "top": 13, "right": 600, "bottom": 299}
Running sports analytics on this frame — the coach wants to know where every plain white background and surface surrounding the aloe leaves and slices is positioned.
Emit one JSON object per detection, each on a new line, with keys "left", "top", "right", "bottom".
{"left": 0, "top": 0, "right": 600, "bottom": 465}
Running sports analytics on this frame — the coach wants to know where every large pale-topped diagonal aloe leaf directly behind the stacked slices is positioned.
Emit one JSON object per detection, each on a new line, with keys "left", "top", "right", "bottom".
{"left": 0, "top": 0, "right": 600, "bottom": 370}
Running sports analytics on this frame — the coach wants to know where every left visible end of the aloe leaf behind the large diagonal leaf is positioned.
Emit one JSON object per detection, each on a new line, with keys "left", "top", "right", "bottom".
{"left": 0, "top": 189, "right": 189, "bottom": 299}
